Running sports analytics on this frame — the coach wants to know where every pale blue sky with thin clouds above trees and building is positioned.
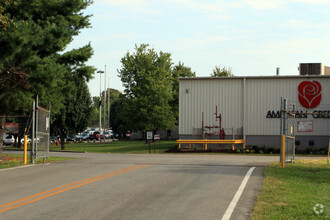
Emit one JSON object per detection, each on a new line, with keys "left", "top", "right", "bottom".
{"left": 68, "top": 0, "right": 330, "bottom": 96}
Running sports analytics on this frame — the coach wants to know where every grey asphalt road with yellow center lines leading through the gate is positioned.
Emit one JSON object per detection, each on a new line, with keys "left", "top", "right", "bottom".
{"left": 0, "top": 153, "right": 279, "bottom": 220}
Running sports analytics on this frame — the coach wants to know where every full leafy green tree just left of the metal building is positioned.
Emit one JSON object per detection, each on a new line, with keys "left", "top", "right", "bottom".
{"left": 118, "top": 44, "right": 175, "bottom": 134}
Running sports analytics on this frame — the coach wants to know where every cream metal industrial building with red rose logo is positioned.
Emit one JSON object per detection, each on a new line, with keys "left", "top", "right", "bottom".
{"left": 179, "top": 65, "right": 330, "bottom": 148}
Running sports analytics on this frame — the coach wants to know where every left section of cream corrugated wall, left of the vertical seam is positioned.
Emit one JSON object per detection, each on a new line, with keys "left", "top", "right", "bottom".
{"left": 179, "top": 78, "right": 243, "bottom": 135}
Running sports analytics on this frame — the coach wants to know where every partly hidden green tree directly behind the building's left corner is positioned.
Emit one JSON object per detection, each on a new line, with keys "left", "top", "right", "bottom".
{"left": 171, "top": 62, "right": 196, "bottom": 124}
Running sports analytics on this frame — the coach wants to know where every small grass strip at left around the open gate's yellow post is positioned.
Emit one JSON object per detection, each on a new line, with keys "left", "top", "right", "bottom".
{"left": 0, "top": 154, "right": 72, "bottom": 169}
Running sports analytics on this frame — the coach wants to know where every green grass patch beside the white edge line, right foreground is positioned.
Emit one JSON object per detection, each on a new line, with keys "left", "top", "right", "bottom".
{"left": 252, "top": 159, "right": 330, "bottom": 219}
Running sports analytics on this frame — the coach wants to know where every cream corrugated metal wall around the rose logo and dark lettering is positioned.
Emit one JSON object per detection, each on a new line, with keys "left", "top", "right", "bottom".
{"left": 179, "top": 76, "right": 330, "bottom": 136}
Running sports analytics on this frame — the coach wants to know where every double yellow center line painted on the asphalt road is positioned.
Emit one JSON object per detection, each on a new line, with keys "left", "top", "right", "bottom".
{"left": 0, "top": 164, "right": 150, "bottom": 213}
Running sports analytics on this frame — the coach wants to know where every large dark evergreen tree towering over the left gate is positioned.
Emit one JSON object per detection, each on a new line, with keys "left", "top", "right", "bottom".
{"left": 0, "top": 0, "right": 93, "bottom": 157}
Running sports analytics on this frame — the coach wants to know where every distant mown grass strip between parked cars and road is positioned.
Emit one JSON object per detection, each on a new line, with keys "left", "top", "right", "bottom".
{"left": 50, "top": 140, "right": 177, "bottom": 154}
